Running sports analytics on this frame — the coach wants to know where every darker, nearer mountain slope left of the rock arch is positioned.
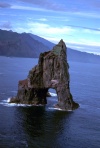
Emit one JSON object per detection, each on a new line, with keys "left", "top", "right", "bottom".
{"left": 0, "top": 30, "right": 50, "bottom": 58}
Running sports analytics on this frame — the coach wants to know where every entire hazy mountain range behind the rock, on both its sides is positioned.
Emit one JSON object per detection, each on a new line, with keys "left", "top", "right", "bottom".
{"left": 0, "top": 30, "right": 100, "bottom": 63}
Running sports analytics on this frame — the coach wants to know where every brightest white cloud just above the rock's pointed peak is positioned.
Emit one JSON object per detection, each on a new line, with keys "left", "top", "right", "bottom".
{"left": 14, "top": 21, "right": 75, "bottom": 42}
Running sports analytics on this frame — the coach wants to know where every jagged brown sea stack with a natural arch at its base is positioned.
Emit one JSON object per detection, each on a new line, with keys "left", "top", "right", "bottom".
{"left": 10, "top": 40, "right": 79, "bottom": 110}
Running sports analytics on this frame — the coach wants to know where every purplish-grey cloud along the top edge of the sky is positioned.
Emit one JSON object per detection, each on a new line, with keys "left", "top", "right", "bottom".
{"left": 19, "top": 0, "right": 100, "bottom": 13}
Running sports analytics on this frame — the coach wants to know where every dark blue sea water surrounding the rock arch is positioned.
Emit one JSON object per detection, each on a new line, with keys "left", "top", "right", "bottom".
{"left": 0, "top": 56, "right": 100, "bottom": 148}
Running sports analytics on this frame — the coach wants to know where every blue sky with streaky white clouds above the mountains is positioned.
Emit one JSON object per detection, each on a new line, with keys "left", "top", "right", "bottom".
{"left": 0, "top": 0, "right": 100, "bottom": 55}
